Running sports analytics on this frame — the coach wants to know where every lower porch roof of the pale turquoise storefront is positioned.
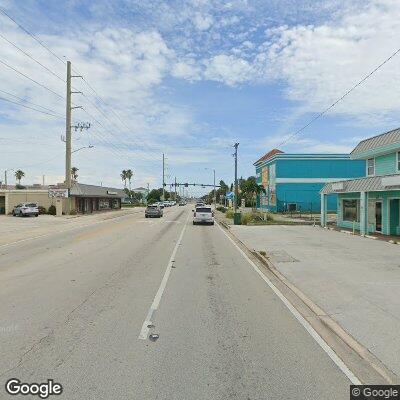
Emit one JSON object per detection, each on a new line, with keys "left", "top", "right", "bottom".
{"left": 320, "top": 174, "right": 400, "bottom": 194}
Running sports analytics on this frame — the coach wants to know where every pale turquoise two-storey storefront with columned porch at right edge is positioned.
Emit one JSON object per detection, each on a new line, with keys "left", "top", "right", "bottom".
{"left": 320, "top": 129, "right": 400, "bottom": 236}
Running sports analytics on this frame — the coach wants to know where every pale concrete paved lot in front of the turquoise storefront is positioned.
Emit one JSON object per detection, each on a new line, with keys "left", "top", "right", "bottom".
{"left": 230, "top": 225, "right": 400, "bottom": 376}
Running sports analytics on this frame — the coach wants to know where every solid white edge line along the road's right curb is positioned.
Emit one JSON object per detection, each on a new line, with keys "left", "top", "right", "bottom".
{"left": 217, "top": 224, "right": 362, "bottom": 385}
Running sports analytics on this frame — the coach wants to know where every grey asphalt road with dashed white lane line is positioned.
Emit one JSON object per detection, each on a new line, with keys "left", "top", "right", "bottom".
{"left": 0, "top": 206, "right": 350, "bottom": 400}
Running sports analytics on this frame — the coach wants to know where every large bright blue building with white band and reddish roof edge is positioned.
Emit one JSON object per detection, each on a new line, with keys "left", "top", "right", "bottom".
{"left": 254, "top": 149, "right": 365, "bottom": 213}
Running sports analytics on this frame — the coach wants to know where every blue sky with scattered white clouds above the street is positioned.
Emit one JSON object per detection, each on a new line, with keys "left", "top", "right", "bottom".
{"left": 0, "top": 0, "right": 400, "bottom": 194}
